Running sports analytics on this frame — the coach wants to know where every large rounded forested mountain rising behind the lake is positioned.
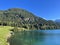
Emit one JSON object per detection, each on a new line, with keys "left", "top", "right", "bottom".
{"left": 0, "top": 8, "right": 60, "bottom": 30}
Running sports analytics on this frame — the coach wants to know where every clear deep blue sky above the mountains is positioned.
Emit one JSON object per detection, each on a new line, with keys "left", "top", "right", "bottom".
{"left": 0, "top": 0, "right": 60, "bottom": 20}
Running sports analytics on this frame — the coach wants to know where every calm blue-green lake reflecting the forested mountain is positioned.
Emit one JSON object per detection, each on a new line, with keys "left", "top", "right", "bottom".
{"left": 9, "top": 30, "right": 60, "bottom": 45}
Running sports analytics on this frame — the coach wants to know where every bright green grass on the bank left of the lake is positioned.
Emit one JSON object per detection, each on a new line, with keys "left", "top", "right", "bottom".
{"left": 0, "top": 26, "right": 12, "bottom": 45}
